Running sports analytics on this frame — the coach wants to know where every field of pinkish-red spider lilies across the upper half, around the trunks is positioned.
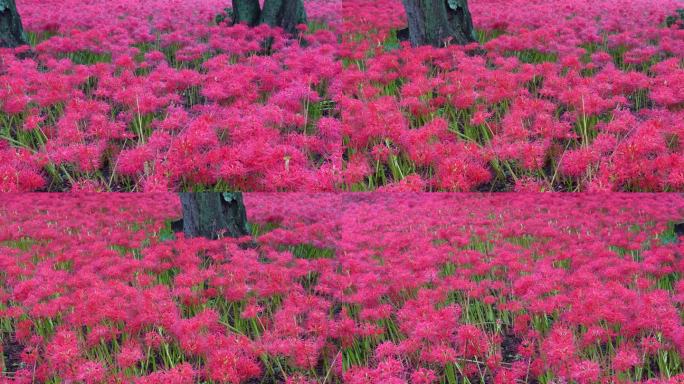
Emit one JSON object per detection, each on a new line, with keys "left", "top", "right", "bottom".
{"left": 0, "top": 0, "right": 684, "bottom": 192}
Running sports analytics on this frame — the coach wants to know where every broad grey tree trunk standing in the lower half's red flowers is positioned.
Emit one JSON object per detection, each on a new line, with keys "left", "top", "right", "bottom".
{"left": 180, "top": 192, "right": 250, "bottom": 239}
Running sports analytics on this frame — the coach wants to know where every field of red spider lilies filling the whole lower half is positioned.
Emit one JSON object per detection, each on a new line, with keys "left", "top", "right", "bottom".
{"left": 0, "top": 193, "right": 684, "bottom": 384}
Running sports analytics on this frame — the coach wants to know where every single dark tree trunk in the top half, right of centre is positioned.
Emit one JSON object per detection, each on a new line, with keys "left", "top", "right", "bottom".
{"left": 403, "top": 0, "right": 476, "bottom": 47}
